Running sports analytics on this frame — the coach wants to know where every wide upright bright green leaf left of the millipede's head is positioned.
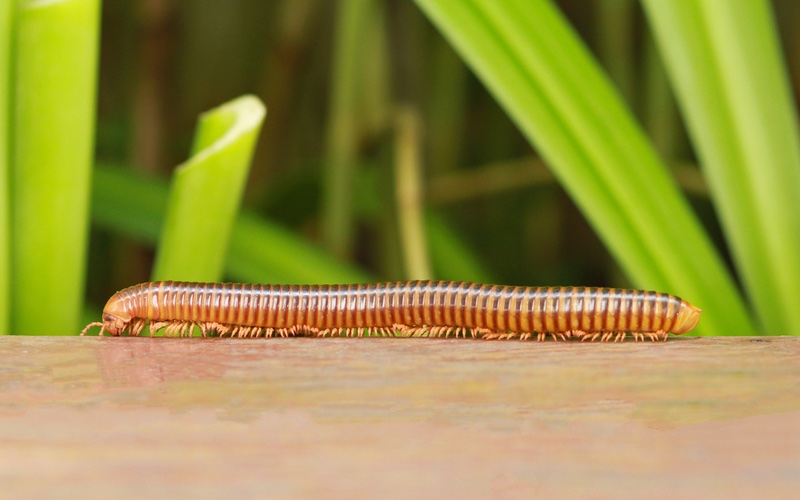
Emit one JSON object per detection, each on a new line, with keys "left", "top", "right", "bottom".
{"left": 11, "top": 0, "right": 100, "bottom": 335}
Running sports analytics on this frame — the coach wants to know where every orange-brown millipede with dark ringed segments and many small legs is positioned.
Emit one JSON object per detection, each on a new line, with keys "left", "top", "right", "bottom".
{"left": 81, "top": 281, "right": 701, "bottom": 341}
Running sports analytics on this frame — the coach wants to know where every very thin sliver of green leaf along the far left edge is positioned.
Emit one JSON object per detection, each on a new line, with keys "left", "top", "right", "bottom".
{"left": 0, "top": 0, "right": 14, "bottom": 335}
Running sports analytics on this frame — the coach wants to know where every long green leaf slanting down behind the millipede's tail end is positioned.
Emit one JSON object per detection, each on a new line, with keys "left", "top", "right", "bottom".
{"left": 416, "top": 0, "right": 755, "bottom": 335}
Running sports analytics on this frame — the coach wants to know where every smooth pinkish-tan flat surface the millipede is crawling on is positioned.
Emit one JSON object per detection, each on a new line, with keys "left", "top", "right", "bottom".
{"left": 0, "top": 337, "right": 800, "bottom": 498}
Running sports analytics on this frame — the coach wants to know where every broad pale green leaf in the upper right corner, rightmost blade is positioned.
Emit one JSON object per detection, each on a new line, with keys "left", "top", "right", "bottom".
{"left": 643, "top": 0, "right": 800, "bottom": 335}
